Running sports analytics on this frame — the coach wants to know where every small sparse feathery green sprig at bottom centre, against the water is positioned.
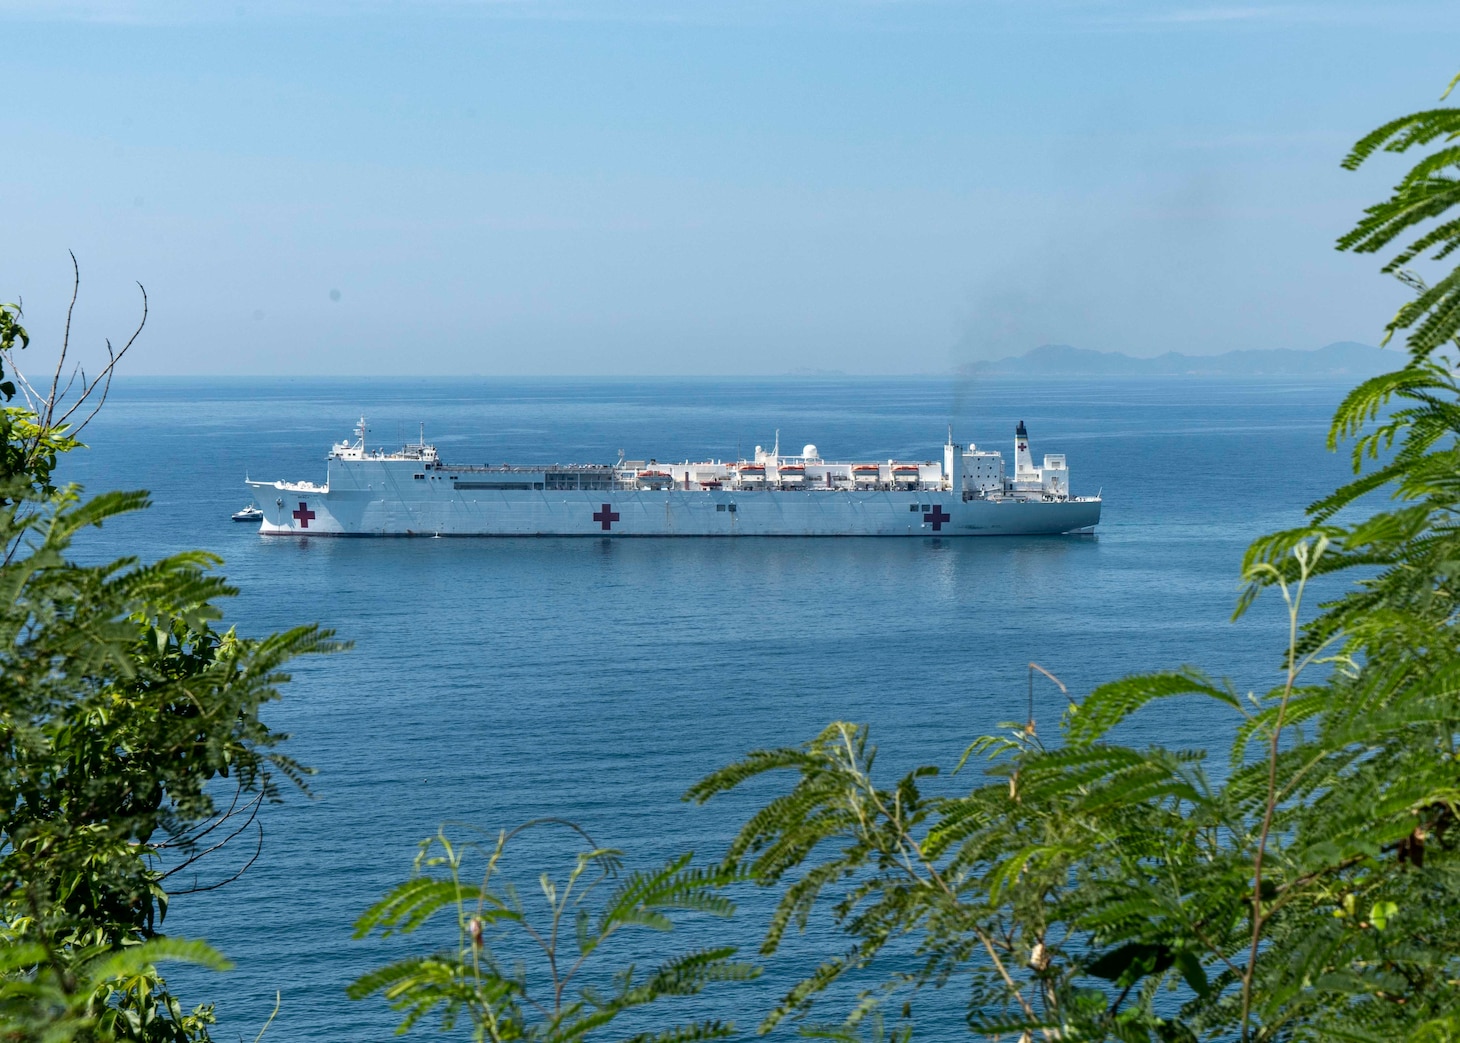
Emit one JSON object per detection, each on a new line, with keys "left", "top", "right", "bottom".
{"left": 349, "top": 820, "right": 758, "bottom": 1043}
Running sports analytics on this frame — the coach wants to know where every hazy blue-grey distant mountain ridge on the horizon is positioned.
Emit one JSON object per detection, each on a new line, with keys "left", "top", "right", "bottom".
{"left": 958, "top": 340, "right": 1406, "bottom": 380}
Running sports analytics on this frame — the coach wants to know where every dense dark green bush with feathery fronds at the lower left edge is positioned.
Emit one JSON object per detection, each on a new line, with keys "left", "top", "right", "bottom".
{"left": 0, "top": 476, "right": 331, "bottom": 1040}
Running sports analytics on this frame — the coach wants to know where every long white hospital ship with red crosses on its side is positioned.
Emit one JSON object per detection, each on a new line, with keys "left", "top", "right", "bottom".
{"left": 248, "top": 418, "right": 1102, "bottom": 536}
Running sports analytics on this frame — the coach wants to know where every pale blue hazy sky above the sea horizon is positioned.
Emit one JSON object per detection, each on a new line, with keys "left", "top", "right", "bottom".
{"left": 0, "top": 0, "right": 1460, "bottom": 375}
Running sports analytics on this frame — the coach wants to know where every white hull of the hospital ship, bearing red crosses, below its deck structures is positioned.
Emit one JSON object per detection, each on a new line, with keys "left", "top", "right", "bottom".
{"left": 256, "top": 484, "right": 1101, "bottom": 536}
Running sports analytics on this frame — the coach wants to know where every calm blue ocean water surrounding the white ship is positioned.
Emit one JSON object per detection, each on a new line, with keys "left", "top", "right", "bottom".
{"left": 54, "top": 378, "right": 1348, "bottom": 1040}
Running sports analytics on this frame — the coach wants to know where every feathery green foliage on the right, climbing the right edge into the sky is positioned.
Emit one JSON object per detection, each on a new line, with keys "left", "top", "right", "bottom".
{"left": 688, "top": 73, "right": 1460, "bottom": 1043}
